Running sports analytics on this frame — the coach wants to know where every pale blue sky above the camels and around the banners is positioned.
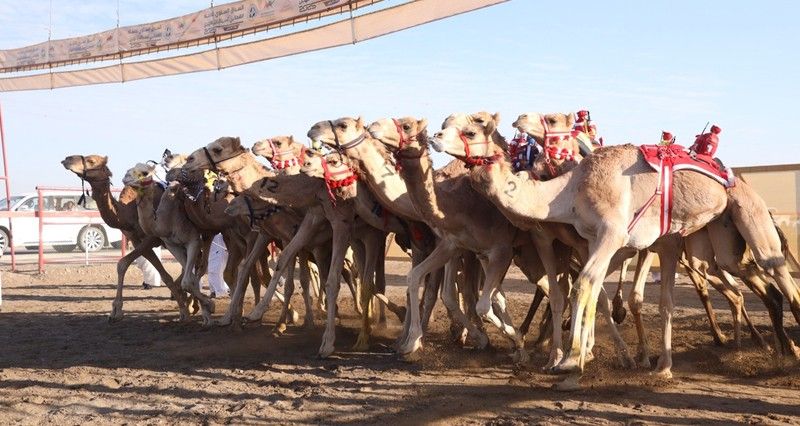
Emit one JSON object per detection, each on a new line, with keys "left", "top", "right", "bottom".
{"left": 0, "top": 0, "right": 800, "bottom": 193}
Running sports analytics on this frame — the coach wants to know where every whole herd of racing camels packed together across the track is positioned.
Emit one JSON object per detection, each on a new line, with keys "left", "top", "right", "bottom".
{"left": 62, "top": 112, "right": 800, "bottom": 389}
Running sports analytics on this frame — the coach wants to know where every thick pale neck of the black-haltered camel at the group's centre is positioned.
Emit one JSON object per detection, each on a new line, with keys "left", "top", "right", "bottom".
{"left": 347, "top": 136, "right": 421, "bottom": 220}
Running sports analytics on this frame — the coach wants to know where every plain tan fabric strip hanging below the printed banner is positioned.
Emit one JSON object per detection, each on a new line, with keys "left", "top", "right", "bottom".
{"left": 0, "top": 0, "right": 508, "bottom": 92}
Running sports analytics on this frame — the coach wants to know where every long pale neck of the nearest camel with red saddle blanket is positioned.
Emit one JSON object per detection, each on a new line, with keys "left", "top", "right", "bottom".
{"left": 470, "top": 153, "right": 575, "bottom": 229}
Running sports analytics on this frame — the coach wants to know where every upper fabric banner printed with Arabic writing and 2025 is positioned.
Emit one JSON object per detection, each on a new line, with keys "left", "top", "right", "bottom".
{"left": 0, "top": 0, "right": 379, "bottom": 72}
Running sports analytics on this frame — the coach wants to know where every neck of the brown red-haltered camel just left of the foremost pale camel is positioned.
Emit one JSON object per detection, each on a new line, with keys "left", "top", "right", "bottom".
{"left": 399, "top": 148, "right": 448, "bottom": 229}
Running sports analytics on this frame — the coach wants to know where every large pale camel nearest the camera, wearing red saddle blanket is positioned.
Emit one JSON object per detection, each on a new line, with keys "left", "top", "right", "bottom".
{"left": 433, "top": 114, "right": 797, "bottom": 387}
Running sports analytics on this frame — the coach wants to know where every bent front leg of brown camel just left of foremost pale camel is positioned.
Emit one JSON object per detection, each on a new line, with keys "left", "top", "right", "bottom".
{"left": 398, "top": 240, "right": 457, "bottom": 355}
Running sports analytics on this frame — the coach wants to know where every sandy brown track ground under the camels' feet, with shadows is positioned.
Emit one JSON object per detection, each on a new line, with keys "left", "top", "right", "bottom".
{"left": 0, "top": 262, "right": 800, "bottom": 425}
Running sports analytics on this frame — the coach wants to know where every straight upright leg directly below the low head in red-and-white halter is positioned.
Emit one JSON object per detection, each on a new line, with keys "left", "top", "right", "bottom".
{"left": 317, "top": 217, "right": 353, "bottom": 358}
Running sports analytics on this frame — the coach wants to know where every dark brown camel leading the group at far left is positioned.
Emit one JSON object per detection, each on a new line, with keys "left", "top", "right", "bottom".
{"left": 61, "top": 155, "right": 184, "bottom": 322}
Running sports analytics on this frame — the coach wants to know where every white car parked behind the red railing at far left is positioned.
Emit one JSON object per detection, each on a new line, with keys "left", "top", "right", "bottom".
{"left": 0, "top": 191, "right": 122, "bottom": 253}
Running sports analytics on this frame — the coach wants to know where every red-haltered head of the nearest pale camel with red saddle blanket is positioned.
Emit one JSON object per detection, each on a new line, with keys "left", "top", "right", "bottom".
{"left": 431, "top": 117, "right": 503, "bottom": 161}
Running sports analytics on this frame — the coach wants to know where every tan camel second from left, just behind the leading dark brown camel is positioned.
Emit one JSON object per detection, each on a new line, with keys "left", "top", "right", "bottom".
{"left": 122, "top": 163, "right": 214, "bottom": 326}
